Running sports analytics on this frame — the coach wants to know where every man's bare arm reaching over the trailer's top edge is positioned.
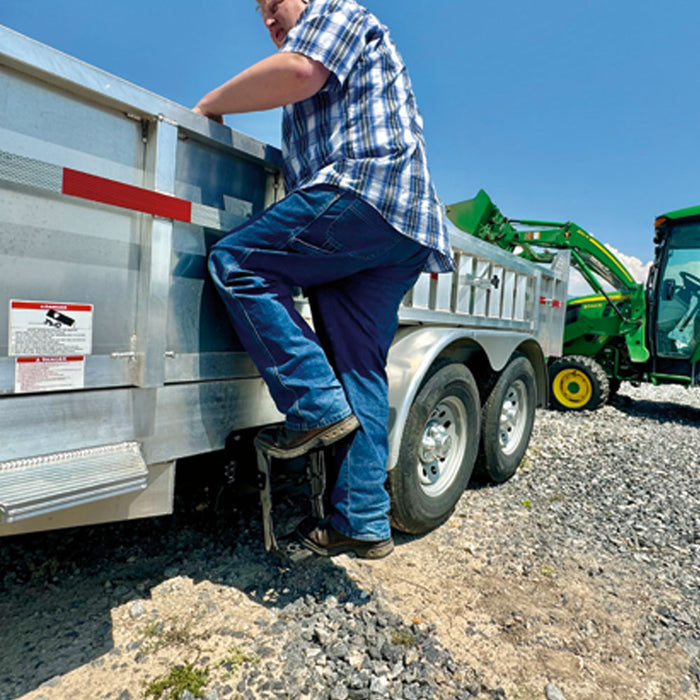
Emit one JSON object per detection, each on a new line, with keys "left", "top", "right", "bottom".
{"left": 192, "top": 51, "right": 329, "bottom": 122}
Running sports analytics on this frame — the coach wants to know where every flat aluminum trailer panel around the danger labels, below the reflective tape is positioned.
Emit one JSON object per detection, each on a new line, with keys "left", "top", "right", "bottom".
{"left": 0, "top": 188, "right": 141, "bottom": 372}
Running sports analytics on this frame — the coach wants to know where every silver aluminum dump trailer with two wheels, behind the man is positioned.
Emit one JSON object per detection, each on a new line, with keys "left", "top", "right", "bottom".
{"left": 0, "top": 27, "right": 568, "bottom": 535}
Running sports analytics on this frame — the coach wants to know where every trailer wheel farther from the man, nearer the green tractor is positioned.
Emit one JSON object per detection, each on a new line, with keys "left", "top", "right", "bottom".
{"left": 476, "top": 357, "right": 537, "bottom": 483}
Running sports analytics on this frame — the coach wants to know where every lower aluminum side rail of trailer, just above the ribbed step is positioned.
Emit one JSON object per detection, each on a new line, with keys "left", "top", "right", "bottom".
{"left": 0, "top": 377, "right": 282, "bottom": 464}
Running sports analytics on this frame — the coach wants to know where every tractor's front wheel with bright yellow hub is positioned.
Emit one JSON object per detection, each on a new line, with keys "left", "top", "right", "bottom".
{"left": 549, "top": 355, "right": 610, "bottom": 411}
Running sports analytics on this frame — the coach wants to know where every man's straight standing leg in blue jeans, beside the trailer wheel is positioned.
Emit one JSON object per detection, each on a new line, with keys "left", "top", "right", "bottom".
{"left": 312, "top": 252, "right": 425, "bottom": 541}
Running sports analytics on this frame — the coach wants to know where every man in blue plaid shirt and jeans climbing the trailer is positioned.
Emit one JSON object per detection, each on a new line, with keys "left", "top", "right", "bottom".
{"left": 194, "top": 0, "right": 452, "bottom": 558}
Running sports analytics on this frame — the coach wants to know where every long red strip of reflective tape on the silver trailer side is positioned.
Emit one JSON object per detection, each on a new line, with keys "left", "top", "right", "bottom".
{"left": 61, "top": 168, "right": 192, "bottom": 223}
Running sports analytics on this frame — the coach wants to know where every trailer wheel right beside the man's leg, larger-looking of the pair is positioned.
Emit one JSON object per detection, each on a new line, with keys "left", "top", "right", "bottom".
{"left": 387, "top": 364, "right": 480, "bottom": 534}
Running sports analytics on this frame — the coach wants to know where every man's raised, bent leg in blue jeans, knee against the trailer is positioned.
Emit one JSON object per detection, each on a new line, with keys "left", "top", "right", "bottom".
{"left": 209, "top": 187, "right": 417, "bottom": 446}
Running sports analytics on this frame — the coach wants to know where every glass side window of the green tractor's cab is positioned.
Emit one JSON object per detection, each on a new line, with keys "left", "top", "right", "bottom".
{"left": 656, "top": 221, "right": 700, "bottom": 359}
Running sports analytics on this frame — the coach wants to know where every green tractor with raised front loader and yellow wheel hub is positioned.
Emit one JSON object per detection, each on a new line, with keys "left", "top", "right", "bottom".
{"left": 447, "top": 190, "right": 700, "bottom": 411}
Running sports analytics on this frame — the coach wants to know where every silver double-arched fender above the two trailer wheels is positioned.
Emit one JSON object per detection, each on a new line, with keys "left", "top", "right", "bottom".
{"left": 387, "top": 326, "right": 547, "bottom": 470}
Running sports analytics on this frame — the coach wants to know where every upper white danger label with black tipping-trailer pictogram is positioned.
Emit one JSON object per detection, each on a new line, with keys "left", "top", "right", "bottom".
{"left": 8, "top": 300, "right": 93, "bottom": 357}
